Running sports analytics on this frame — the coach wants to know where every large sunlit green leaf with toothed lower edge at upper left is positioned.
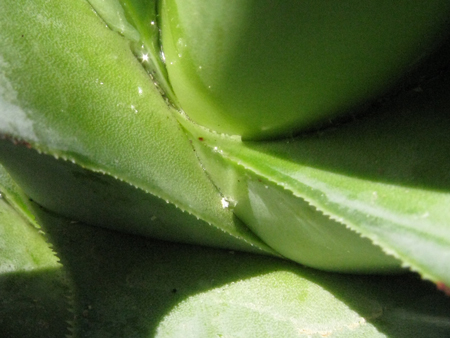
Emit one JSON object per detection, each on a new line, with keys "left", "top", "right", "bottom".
{"left": 0, "top": 0, "right": 270, "bottom": 251}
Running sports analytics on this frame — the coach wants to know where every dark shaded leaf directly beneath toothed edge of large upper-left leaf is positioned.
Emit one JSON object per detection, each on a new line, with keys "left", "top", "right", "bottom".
{"left": 0, "top": 140, "right": 270, "bottom": 253}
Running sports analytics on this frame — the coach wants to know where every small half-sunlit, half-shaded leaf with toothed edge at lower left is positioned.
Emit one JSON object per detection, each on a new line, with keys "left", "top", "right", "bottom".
{"left": 0, "top": 176, "right": 72, "bottom": 338}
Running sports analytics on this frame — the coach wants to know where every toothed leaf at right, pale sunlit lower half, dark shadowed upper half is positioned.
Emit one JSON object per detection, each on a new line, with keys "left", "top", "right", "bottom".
{"left": 181, "top": 66, "right": 450, "bottom": 284}
